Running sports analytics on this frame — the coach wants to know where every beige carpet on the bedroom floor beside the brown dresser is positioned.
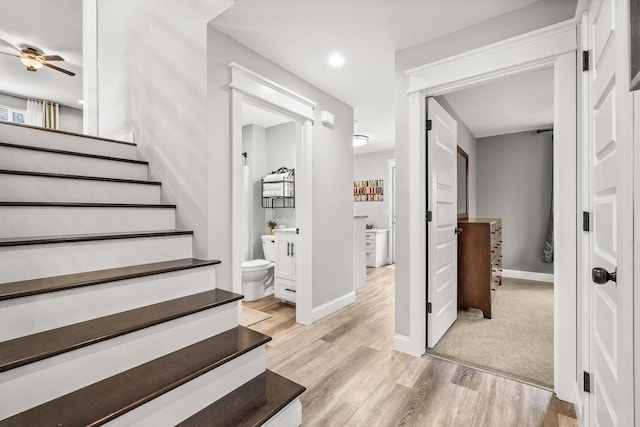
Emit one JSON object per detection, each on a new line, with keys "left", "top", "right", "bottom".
{"left": 427, "top": 279, "right": 553, "bottom": 388}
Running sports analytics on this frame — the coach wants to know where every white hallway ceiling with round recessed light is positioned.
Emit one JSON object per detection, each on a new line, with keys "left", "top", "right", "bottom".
{"left": 212, "top": 0, "right": 536, "bottom": 153}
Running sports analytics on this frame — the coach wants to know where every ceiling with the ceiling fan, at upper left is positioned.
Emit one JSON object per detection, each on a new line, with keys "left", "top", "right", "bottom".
{"left": 0, "top": 0, "right": 82, "bottom": 108}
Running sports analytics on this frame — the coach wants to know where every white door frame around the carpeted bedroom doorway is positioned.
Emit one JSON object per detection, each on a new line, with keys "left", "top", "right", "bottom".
{"left": 394, "top": 19, "right": 577, "bottom": 402}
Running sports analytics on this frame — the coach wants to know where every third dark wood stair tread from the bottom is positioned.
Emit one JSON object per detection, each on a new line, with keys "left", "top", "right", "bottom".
{"left": 0, "top": 289, "right": 242, "bottom": 372}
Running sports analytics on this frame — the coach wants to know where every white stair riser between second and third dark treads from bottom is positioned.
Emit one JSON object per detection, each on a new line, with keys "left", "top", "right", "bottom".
{"left": 0, "top": 303, "right": 238, "bottom": 419}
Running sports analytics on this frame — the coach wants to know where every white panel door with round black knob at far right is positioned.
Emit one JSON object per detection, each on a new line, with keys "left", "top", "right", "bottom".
{"left": 587, "top": 0, "right": 627, "bottom": 426}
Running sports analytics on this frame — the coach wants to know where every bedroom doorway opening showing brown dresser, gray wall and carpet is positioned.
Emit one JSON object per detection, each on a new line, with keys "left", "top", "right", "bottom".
{"left": 427, "top": 68, "right": 554, "bottom": 389}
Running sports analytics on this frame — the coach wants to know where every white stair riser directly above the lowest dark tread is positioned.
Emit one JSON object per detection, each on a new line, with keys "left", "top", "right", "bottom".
{"left": 105, "top": 346, "right": 266, "bottom": 427}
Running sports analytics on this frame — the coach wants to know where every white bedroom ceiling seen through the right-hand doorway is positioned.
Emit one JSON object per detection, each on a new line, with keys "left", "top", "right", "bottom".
{"left": 445, "top": 68, "right": 553, "bottom": 138}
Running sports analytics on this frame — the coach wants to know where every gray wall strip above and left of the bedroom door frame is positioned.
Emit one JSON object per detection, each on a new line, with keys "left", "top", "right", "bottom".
{"left": 396, "top": 0, "right": 576, "bottom": 342}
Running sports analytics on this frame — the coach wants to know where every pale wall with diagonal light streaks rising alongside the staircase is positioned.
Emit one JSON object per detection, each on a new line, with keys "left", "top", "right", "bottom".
{"left": 94, "top": 0, "right": 232, "bottom": 288}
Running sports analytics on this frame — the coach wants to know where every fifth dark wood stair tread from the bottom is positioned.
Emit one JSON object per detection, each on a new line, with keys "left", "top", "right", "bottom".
{"left": 0, "top": 230, "right": 193, "bottom": 247}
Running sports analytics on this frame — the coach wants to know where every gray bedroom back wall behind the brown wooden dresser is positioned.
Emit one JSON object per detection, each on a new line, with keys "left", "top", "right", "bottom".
{"left": 477, "top": 132, "right": 553, "bottom": 273}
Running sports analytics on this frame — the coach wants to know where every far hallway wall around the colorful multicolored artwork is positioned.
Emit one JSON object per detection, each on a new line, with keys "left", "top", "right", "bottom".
{"left": 353, "top": 150, "right": 395, "bottom": 229}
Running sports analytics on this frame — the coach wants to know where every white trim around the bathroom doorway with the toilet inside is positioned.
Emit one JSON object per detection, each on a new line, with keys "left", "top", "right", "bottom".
{"left": 229, "top": 62, "right": 316, "bottom": 325}
